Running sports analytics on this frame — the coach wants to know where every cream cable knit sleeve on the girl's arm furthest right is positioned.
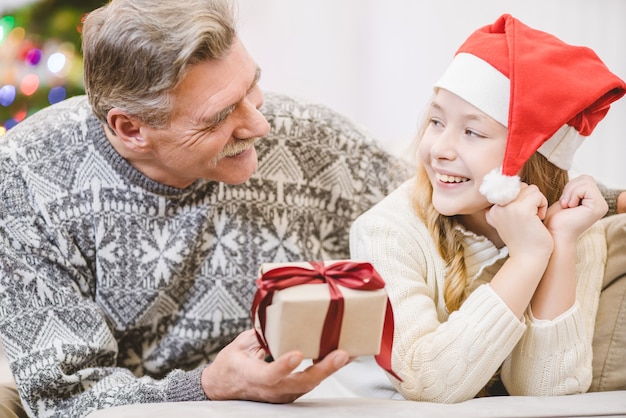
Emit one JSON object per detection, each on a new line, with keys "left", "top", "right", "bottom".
{"left": 502, "top": 224, "right": 606, "bottom": 396}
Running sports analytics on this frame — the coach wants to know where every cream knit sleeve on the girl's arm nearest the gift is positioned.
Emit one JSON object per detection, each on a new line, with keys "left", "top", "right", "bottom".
{"left": 350, "top": 182, "right": 525, "bottom": 403}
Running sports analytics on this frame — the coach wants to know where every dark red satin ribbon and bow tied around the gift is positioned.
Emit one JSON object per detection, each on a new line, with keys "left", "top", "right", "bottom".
{"left": 251, "top": 261, "right": 402, "bottom": 380}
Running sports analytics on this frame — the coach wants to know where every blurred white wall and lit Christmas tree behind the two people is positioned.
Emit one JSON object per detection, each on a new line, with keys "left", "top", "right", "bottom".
{"left": 0, "top": 0, "right": 626, "bottom": 187}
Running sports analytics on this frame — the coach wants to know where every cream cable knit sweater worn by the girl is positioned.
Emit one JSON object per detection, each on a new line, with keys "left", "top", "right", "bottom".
{"left": 340, "top": 181, "right": 606, "bottom": 403}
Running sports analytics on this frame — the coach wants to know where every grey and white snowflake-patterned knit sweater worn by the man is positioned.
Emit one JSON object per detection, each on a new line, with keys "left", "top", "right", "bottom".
{"left": 0, "top": 94, "right": 404, "bottom": 417}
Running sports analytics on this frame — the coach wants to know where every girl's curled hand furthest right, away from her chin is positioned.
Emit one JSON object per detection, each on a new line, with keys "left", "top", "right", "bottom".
{"left": 544, "top": 175, "right": 609, "bottom": 241}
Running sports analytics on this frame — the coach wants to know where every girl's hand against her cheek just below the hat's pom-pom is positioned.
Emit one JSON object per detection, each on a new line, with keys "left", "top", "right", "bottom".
{"left": 487, "top": 183, "right": 554, "bottom": 258}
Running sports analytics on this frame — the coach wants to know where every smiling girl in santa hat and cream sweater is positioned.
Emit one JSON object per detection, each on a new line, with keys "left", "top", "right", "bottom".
{"left": 340, "top": 15, "right": 626, "bottom": 402}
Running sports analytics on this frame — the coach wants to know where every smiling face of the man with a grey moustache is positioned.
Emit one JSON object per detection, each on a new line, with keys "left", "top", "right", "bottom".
{"left": 137, "top": 40, "right": 269, "bottom": 188}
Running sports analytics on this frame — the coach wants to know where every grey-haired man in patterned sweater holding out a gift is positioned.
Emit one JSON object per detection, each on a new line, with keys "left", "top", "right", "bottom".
{"left": 0, "top": 0, "right": 394, "bottom": 417}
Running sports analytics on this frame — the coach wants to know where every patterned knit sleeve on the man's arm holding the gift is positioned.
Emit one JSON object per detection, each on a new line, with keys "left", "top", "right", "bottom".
{"left": 0, "top": 167, "right": 206, "bottom": 417}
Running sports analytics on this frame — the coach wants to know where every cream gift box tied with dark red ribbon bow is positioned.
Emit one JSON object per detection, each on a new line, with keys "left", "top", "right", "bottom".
{"left": 251, "top": 260, "right": 393, "bottom": 359}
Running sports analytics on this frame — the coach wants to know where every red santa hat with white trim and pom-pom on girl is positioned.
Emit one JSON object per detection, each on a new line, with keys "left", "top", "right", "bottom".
{"left": 435, "top": 14, "right": 626, "bottom": 205}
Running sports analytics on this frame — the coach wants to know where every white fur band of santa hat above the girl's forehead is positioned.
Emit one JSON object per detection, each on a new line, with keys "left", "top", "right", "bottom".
{"left": 435, "top": 52, "right": 511, "bottom": 127}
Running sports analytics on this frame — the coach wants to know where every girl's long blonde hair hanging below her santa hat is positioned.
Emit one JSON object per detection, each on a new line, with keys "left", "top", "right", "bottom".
{"left": 413, "top": 121, "right": 569, "bottom": 312}
